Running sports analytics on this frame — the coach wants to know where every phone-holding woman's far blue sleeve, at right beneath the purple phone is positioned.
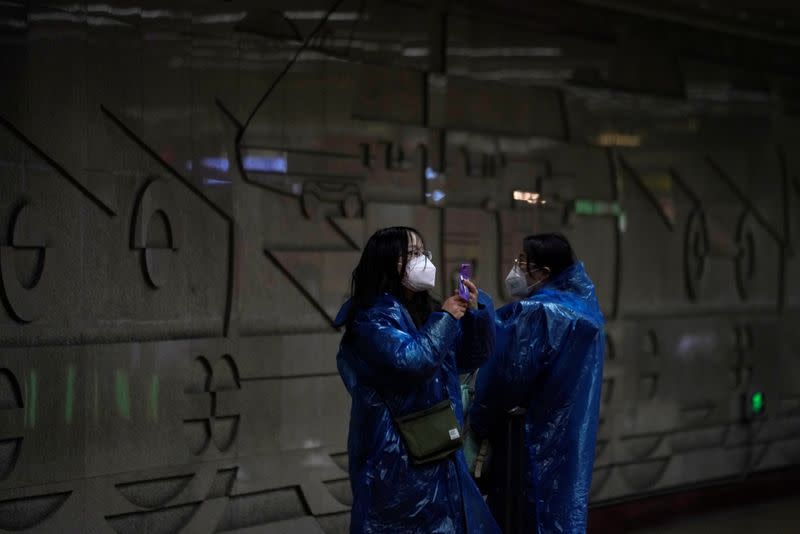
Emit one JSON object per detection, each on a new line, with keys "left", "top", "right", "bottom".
{"left": 456, "top": 290, "right": 495, "bottom": 373}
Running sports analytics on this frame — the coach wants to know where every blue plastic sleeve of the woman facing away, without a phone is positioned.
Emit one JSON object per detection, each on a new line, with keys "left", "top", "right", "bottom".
{"left": 469, "top": 302, "right": 550, "bottom": 438}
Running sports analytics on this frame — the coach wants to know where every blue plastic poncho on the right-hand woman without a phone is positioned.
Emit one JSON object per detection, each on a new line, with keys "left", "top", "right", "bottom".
{"left": 469, "top": 263, "right": 605, "bottom": 534}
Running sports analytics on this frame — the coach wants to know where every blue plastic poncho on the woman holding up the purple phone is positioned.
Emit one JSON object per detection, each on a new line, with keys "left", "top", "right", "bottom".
{"left": 337, "top": 293, "right": 500, "bottom": 534}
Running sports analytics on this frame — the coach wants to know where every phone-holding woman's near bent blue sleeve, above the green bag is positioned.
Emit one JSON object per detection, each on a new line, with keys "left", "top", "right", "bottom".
{"left": 355, "top": 309, "right": 458, "bottom": 382}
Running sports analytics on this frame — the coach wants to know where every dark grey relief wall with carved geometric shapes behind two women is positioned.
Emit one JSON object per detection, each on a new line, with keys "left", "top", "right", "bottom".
{"left": 0, "top": 0, "right": 800, "bottom": 533}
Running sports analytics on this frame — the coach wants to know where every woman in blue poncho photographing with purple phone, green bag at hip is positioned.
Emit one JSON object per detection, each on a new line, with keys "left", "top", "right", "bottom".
{"left": 336, "top": 227, "right": 499, "bottom": 534}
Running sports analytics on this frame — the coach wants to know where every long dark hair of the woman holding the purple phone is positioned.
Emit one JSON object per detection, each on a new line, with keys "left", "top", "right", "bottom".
{"left": 347, "top": 226, "right": 437, "bottom": 327}
